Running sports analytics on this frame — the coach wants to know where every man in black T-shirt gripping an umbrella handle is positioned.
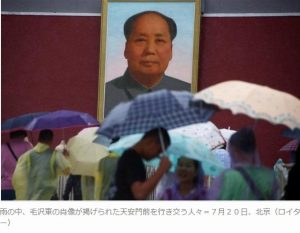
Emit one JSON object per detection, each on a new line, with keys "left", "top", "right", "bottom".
{"left": 112, "top": 128, "right": 171, "bottom": 200}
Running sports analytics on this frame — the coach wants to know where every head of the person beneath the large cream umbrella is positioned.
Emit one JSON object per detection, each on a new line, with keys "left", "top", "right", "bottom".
{"left": 228, "top": 128, "right": 258, "bottom": 164}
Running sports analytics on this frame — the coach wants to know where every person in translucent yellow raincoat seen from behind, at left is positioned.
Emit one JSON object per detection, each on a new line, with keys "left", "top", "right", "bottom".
{"left": 12, "top": 129, "right": 71, "bottom": 200}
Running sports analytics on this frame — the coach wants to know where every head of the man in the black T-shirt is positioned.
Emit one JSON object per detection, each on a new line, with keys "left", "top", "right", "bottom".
{"left": 139, "top": 128, "right": 171, "bottom": 160}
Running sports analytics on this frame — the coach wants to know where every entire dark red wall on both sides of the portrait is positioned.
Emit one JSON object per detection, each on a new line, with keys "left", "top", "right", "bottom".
{"left": 1, "top": 15, "right": 300, "bottom": 166}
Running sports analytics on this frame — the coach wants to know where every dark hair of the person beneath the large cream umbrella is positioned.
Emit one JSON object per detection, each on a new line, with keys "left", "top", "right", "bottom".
{"left": 229, "top": 128, "right": 256, "bottom": 154}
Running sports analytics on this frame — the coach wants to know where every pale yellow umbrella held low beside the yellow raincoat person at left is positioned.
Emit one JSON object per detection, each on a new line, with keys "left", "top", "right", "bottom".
{"left": 67, "top": 135, "right": 108, "bottom": 176}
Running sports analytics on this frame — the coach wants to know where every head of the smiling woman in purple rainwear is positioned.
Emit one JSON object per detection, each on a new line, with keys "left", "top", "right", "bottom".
{"left": 176, "top": 156, "right": 204, "bottom": 185}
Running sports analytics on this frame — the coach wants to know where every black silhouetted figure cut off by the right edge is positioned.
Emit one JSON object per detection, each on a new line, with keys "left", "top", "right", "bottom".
{"left": 282, "top": 144, "right": 300, "bottom": 200}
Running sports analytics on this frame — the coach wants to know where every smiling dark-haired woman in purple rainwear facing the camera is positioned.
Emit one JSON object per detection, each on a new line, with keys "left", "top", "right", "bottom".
{"left": 159, "top": 157, "right": 206, "bottom": 200}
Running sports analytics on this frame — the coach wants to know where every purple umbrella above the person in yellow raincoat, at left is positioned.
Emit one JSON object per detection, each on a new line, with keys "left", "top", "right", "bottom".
{"left": 25, "top": 110, "right": 99, "bottom": 130}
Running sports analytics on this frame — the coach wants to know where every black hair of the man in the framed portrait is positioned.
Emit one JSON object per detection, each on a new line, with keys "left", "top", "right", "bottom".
{"left": 124, "top": 11, "right": 177, "bottom": 40}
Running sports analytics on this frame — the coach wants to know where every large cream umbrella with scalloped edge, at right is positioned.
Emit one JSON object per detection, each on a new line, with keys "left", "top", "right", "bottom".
{"left": 194, "top": 81, "right": 300, "bottom": 129}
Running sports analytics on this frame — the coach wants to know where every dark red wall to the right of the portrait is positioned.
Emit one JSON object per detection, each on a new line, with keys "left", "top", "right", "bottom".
{"left": 198, "top": 17, "right": 300, "bottom": 166}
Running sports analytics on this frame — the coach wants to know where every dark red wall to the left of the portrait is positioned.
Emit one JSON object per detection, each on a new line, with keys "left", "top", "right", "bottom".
{"left": 1, "top": 15, "right": 100, "bottom": 118}
